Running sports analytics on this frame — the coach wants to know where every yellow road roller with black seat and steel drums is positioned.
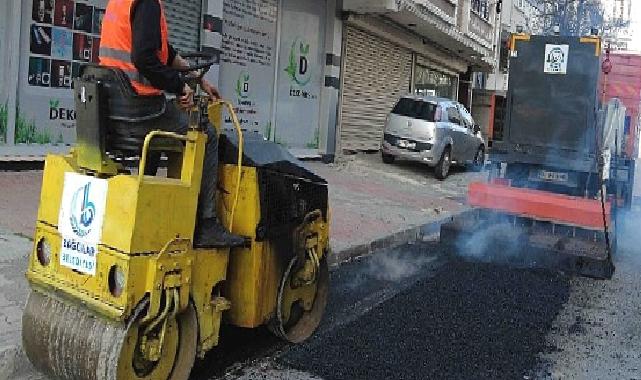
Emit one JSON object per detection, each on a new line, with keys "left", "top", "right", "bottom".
{"left": 22, "top": 53, "right": 329, "bottom": 380}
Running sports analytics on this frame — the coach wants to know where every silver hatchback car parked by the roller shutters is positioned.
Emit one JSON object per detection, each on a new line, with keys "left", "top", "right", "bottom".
{"left": 382, "top": 96, "right": 485, "bottom": 180}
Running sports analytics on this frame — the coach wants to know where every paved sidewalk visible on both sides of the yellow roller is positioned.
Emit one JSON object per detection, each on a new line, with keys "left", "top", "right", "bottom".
{"left": 0, "top": 155, "right": 482, "bottom": 380}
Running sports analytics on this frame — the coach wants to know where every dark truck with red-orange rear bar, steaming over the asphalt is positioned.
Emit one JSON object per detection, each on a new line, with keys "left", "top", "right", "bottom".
{"left": 441, "top": 34, "right": 634, "bottom": 278}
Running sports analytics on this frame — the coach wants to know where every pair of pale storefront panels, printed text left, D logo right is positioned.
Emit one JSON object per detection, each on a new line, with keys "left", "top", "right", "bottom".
{"left": 219, "top": 0, "right": 326, "bottom": 149}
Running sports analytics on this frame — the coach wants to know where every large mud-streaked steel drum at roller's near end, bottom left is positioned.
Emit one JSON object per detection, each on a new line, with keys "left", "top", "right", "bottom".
{"left": 22, "top": 291, "right": 198, "bottom": 380}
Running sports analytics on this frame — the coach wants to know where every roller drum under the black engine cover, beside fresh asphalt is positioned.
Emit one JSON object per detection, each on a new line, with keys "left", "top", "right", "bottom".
{"left": 269, "top": 257, "right": 329, "bottom": 343}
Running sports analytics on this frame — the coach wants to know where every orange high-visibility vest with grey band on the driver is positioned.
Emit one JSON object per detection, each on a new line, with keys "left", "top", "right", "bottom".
{"left": 100, "top": 0, "right": 169, "bottom": 96}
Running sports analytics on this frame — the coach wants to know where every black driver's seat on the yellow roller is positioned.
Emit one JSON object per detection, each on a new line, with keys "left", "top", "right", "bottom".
{"left": 75, "top": 65, "right": 166, "bottom": 157}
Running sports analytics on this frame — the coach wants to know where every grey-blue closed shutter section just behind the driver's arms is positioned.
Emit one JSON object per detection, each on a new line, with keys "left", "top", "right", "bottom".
{"left": 163, "top": 0, "right": 203, "bottom": 53}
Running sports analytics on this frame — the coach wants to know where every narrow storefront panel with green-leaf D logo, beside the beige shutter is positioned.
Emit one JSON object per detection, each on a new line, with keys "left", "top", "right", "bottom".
{"left": 275, "top": 0, "right": 326, "bottom": 149}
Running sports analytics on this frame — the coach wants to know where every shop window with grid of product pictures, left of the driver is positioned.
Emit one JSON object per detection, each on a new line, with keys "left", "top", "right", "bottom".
{"left": 15, "top": 0, "right": 107, "bottom": 145}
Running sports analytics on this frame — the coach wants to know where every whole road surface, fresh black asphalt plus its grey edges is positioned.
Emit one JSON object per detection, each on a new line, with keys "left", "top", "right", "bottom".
{"left": 192, "top": 243, "right": 641, "bottom": 380}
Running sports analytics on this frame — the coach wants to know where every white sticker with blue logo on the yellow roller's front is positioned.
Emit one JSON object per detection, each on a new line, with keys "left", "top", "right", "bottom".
{"left": 58, "top": 173, "right": 108, "bottom": 276}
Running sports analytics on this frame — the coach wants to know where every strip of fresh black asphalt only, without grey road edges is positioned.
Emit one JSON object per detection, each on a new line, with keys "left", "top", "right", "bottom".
{"left": 277, "top": 251, "right": 570, "bottom": 380}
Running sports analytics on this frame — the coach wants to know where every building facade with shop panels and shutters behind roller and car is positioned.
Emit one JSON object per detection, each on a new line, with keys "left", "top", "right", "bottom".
{"left": 0, "top": 0, "right": 498, "bottom": 160}
